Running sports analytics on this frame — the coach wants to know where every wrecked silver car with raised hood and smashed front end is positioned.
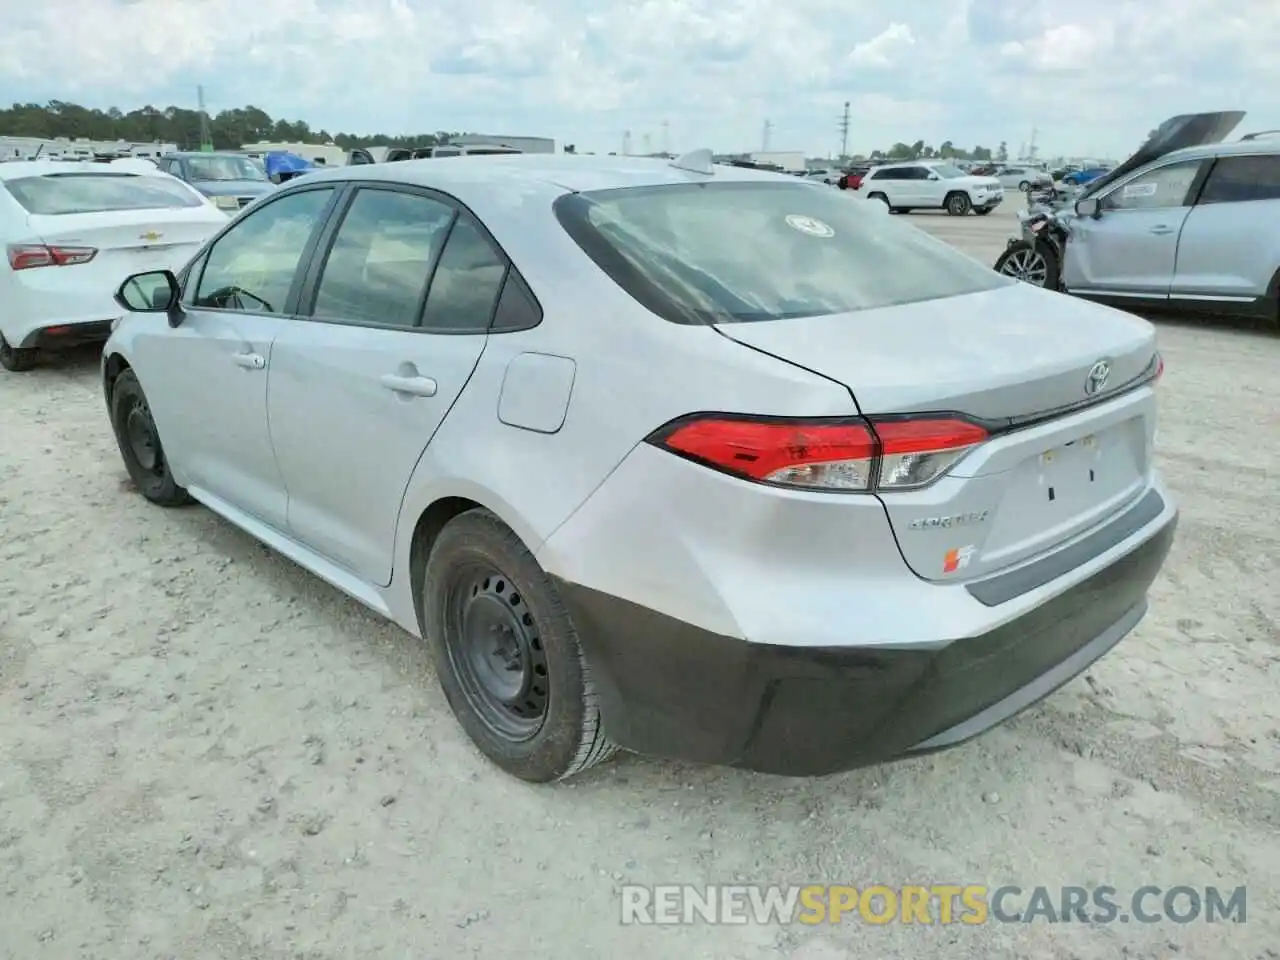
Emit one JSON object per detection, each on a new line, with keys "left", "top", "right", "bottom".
{"left": 997, "top": 111, "right": 1280, "bottom": 321}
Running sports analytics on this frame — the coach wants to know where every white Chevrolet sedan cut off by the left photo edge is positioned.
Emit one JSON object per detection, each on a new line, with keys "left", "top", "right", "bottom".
{"left": 0, "top": 160, "right": 227, "bottom": 371}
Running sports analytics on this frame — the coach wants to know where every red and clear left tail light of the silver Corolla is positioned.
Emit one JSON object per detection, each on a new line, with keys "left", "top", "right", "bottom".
{"left": 649, "top": 413, "right": 988, "bottom": 493}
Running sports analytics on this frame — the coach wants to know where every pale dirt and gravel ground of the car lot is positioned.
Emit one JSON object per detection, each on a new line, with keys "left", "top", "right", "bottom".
{"left": 0, "top": 204, "right": 1280, "bottom": 960}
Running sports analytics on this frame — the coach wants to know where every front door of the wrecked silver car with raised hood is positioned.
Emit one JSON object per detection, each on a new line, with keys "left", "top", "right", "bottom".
{"left": 1062, "top": 160, "right": 1203, "bottom": 300}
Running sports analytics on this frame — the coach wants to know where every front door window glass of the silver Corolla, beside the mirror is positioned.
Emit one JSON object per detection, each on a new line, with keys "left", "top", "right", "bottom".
{"left": 192, "top": 187, "right": 333, "bottom": 314}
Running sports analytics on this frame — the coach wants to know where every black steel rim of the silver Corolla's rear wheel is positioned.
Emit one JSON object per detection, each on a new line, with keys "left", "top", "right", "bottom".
{"left": 444, "top": 563, "right": 550, "bottom": 741}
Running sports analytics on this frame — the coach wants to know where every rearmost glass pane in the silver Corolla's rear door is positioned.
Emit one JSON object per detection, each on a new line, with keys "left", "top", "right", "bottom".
{"left": 422, "top": 216, "right": 507, "bottom": 333}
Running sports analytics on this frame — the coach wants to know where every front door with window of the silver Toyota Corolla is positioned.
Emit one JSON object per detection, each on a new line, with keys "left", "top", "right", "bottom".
{"left": 137, "top": 187, "right": 334, "bottom": 530}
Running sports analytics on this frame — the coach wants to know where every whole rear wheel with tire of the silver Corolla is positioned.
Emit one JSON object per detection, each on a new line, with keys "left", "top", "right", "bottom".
{"left": 421, "top": 509, "right": 617, "bottom": 783}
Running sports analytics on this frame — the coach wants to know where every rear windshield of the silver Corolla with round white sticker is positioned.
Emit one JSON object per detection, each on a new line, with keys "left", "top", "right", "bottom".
{"left": 554, "top": 182, "right": 1016, "bottom": 324}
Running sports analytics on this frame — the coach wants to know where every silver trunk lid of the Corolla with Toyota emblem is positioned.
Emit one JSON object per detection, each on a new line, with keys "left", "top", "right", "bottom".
{"left": 717, "top": 283, "right": 1156, "bottom": 581}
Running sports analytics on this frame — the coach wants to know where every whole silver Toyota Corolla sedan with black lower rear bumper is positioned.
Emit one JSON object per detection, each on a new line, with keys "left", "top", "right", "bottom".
{"left": 102, "top": 151, "right": 1176, "bottom": 782}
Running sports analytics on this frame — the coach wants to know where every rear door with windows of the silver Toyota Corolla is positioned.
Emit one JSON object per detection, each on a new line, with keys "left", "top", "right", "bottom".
{"left": 269, "top": 186, "right": 507, "bottom": 585}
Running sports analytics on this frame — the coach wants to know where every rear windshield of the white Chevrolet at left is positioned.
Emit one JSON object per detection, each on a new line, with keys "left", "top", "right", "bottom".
{"left": 4, "top": 173, "right": 205, "bottom": 216}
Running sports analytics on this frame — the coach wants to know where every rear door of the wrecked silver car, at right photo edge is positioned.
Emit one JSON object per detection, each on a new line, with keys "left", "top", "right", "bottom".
{"left": 1170, "top": 152, "right": 1280, "bottom": 302}
